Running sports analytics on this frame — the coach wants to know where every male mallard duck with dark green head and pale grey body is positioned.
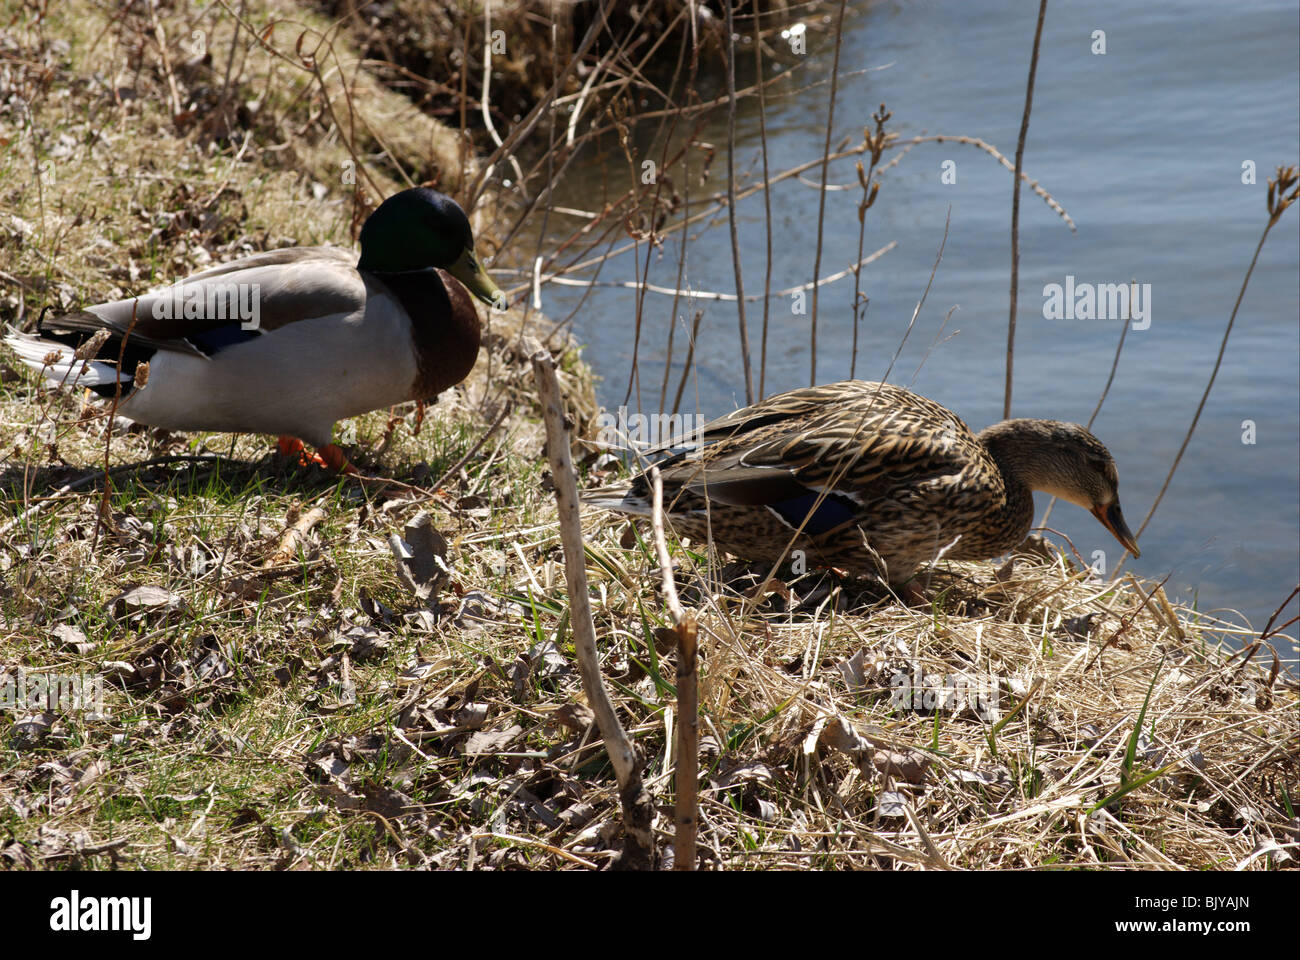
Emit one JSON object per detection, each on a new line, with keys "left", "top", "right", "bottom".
{"left": 5, "top": 187, "right": 504, "bottom": 470}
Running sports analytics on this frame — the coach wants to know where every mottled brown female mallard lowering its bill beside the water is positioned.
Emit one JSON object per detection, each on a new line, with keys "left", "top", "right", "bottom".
{"left": 584, "top": 380, "right": 1138, "bottom": 585}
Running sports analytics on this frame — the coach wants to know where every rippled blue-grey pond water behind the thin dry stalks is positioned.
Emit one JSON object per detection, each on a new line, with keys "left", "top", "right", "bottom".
{"left": 512, "top": 0, "right": 1300, "bottom": 658}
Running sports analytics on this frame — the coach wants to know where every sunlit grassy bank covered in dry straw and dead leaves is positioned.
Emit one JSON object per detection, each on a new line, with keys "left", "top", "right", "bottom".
{"left": 0, "top": 0, "right": 1300, "bottom": 870}
